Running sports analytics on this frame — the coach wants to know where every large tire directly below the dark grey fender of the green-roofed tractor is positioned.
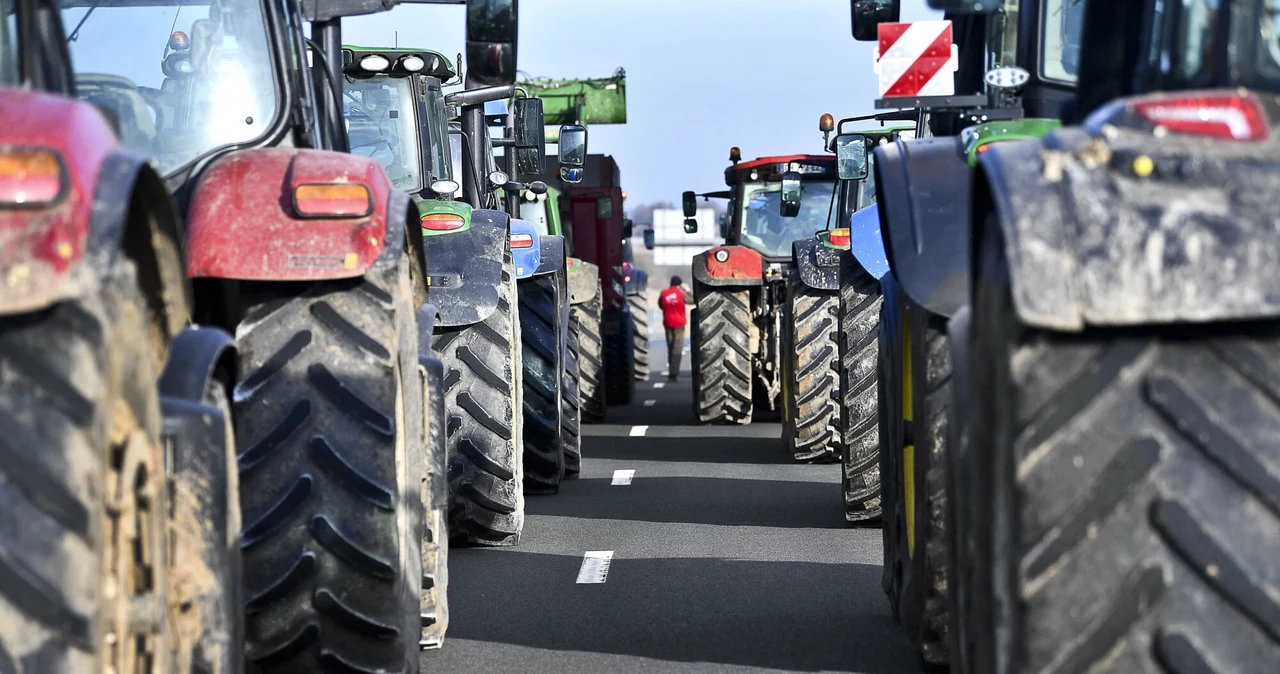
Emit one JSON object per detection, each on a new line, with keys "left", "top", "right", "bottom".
{"left": 434, "top": 251, "right": 525, "bottom": 546}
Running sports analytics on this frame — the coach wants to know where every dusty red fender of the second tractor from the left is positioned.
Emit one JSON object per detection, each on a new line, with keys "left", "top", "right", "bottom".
{"left": 187, "top": 147, "right": 408, "bottom": 281}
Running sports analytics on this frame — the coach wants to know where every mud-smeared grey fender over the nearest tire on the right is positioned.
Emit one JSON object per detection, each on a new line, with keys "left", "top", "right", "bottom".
{"left": 973, "top": 128, "right": 1280, "bottom": 331}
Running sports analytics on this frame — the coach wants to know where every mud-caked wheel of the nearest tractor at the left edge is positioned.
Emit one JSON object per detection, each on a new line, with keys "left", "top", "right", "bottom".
{"left": 0, "top": 261, "right": 172, "bottom": 674}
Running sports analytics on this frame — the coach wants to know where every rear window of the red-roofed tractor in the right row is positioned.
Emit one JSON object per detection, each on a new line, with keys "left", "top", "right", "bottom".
{"left": 741, "top": 182, "right": 836, "bottom": 257}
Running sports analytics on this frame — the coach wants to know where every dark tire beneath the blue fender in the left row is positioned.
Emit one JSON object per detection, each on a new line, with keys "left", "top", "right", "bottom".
{"left": 517, "top": 274, "right": 564, "bottom": 495}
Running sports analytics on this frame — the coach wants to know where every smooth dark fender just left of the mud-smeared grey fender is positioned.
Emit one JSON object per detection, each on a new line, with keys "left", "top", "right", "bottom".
{"left": 876, "top": 137, "right": 973, "bottom": 321}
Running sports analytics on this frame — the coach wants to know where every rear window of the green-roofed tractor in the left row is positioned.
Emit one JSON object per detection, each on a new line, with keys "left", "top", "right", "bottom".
{"left": 342, "top": 75, "right": 422, "bottom": 192}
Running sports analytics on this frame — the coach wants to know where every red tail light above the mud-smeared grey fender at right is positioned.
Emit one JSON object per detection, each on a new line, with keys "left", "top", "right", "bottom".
{"left": 1133, "top": 93, "right": 1271, "bottom": 141}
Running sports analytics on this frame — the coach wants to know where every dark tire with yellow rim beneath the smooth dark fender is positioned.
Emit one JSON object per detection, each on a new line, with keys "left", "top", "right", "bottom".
{"left": 879, "top": 304, "right": 951, "bottom": 666}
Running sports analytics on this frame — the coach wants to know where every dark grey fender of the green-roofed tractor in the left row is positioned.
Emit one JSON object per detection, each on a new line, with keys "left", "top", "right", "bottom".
{"left": 422, "top": 208, "right": 511, "bottom": 327}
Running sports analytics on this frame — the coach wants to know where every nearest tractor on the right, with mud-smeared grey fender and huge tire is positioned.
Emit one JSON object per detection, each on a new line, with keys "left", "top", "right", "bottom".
{"left": 947, "top": 0, "right": 1280, "bottom": 674}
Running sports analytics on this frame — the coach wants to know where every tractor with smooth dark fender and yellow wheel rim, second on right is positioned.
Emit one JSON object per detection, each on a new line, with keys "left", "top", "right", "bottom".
{"left": 852, "top": 0, "right": 1083, "bottom": 665}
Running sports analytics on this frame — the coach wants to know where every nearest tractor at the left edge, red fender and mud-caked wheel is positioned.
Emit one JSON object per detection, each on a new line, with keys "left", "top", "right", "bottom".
{"left": 0, "top": 0, "right": 243, "bottom": 674}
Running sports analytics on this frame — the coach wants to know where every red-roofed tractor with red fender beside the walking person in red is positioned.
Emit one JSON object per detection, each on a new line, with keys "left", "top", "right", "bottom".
{"left": 682, "top": 147, "right": 837, "bottom": 429}
